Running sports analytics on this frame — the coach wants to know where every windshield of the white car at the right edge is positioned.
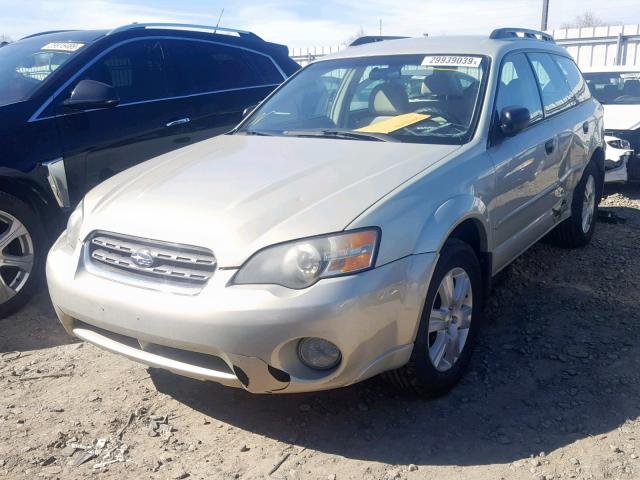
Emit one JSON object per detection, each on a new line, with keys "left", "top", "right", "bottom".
{"left": 584, "top": 71, "right": 640, "bottom": 105}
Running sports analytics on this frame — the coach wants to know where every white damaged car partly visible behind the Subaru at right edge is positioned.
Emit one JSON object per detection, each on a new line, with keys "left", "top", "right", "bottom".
{"left": 584, "top": 66, "right": 640, "bottom": 182}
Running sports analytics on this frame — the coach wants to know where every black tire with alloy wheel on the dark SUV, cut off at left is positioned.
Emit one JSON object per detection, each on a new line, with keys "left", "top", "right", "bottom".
{"left": 0, "top": 192, "right": 45, "bottom": 319}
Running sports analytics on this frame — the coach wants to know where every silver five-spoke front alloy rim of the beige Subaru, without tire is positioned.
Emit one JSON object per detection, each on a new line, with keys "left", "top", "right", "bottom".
{"left": 428, "top": 267, "right": 473, "bottom": 372}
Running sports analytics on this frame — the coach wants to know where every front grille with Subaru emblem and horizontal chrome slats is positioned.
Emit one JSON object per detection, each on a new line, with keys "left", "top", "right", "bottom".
{"left": 85, "top": 232, "right": 216, "bottom": 293}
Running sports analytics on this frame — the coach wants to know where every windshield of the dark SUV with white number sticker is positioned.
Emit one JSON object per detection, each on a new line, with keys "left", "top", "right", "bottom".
{"left": 0, "top": 39, "right": 84, "bottom": 106}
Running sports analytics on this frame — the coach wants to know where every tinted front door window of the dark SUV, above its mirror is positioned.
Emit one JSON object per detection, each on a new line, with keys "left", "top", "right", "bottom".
{"left": 79, "top": 40, "right": 167, "bottom": 104}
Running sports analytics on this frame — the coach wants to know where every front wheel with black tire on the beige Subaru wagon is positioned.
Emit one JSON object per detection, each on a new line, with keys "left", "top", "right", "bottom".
{"left": 387, "top": 239, "right": 483, "bottom": 398}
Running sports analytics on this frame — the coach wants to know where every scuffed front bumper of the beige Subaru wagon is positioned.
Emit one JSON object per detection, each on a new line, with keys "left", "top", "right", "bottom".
{"left": 47, "top": 234, "right": 437, "bottom": 393}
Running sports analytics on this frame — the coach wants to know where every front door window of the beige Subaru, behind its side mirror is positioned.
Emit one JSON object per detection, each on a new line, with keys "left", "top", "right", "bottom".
{"left": 496, "top": 53, "right": 542, "bottom": 123}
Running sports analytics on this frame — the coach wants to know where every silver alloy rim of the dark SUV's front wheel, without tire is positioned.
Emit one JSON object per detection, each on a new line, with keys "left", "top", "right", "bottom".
{"left": 0, "top": 211, "right": 34, "bottom": 304}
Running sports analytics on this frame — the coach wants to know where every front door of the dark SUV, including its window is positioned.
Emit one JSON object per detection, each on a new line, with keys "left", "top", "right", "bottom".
{"left": 56, "top": 39, "right": 190, "bottom": 203}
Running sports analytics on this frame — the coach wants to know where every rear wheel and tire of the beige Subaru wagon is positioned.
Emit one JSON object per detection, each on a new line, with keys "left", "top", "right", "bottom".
{"left": 551, "top": 162, "right": 601, "bottom": 248}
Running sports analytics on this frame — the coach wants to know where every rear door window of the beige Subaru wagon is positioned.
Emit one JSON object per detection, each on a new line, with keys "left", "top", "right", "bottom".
{"left": 527, "top": 53, "right": 575, "bottom": 115}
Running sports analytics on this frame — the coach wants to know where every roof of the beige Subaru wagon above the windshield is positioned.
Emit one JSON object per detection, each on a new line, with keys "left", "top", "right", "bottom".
{"left": 318, "top": 36, "right": 569, "bottom": 62}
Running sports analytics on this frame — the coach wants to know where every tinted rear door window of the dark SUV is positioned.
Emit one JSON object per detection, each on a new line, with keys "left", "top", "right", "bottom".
{"left": 166, "top": 40, "right": 264, "bottom": 96}
